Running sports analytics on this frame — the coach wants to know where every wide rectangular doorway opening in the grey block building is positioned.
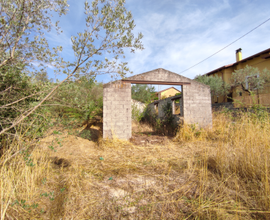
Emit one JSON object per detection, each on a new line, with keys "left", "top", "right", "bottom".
{"left": 131, "top": 84, "right": 183, "bottom": 141}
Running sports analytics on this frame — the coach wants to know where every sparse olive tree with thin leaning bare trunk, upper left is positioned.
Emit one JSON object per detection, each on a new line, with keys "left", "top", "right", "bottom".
{"left": 0, "top": 0, "right": 143, "bottom": 135}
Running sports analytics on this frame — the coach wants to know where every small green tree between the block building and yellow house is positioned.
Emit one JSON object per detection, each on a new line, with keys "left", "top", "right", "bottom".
{"left": 194, "top": 75, "right": 231, "bottom": 96}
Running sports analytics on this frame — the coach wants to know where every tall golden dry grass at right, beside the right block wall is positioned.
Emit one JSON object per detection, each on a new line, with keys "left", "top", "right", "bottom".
{"left": 175, "top": 112, "right": 270, "bottom": 219}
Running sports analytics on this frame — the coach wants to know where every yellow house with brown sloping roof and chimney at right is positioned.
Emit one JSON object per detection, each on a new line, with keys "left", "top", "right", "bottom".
{"left": 204, "top": 48, "right": 270, "bottom": 107}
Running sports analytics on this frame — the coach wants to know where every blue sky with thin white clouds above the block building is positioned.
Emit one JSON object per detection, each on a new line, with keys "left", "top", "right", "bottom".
{"left": 47, "top": 0, "right": 270, "bottom": 89}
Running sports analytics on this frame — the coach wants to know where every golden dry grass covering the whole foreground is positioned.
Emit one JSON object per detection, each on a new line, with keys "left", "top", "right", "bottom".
{"left": 0, "top": 114, "right": 270, "bottom": 219}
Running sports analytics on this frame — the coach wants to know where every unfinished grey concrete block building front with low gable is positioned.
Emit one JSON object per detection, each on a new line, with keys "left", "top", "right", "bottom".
{"left": 103, "top": 68, "right": 212, "bottom": 139}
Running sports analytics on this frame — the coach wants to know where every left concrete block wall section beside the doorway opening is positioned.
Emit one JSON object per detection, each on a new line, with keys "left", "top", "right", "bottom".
{"left": 103, "top": 81, "right": 131, "bottom": 140}
